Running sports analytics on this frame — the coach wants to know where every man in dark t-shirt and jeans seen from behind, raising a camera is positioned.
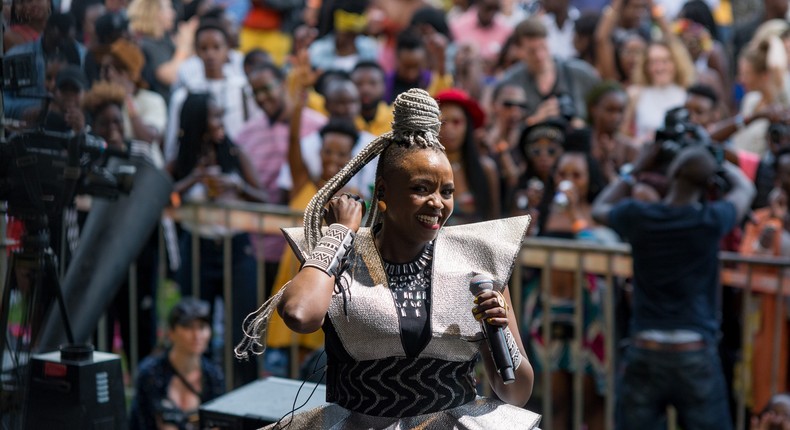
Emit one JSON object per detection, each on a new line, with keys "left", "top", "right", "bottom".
{"left": 593, "top": 144, "right": 755, "bottom": 430}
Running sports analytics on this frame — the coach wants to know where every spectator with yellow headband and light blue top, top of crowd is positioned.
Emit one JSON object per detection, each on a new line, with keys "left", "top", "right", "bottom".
{"left": 309, "top": 0, "right": 379, "bottom": 72}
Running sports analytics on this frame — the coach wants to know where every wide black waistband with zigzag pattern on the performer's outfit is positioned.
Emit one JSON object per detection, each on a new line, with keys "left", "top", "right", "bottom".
{"left": 327, "top": 357, "right": 477, "bottom": 417}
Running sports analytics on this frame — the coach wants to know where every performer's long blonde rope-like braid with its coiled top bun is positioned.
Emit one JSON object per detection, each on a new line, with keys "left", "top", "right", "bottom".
{"left": 234, "top": 88, "right": 444, "bottom": 359}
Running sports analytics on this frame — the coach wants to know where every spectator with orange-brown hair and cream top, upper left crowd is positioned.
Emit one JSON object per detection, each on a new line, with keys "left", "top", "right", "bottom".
{"left": 100, "top": 39, "right": 167, "bottom": 145}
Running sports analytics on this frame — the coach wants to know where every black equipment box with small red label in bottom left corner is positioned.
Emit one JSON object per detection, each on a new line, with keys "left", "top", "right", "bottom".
{"left": 25, "top": 347, "right": 129, "bottom": 430}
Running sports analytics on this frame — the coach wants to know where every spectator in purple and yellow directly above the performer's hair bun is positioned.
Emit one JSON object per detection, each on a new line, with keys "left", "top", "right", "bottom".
{"left": 384, "top": 29, "right": 453, "bottom": 103}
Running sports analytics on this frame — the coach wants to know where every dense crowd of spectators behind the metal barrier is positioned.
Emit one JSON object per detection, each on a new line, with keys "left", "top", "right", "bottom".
{"left": 3, "top": 0, "right": 790, "bottom": 429}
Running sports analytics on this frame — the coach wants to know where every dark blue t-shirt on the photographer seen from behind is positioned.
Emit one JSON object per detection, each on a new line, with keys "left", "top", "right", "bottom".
{"left": 609, "top": 199, "right": 736, "bottom": 340}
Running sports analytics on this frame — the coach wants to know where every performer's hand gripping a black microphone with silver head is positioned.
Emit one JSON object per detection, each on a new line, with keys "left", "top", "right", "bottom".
{"left": 469, "top": 275, "right": 516, "bottom": 384}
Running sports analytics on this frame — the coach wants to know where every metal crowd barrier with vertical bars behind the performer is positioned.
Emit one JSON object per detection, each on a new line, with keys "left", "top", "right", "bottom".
{"left": 6, "top": 203, "right": 790, "bottom": 429}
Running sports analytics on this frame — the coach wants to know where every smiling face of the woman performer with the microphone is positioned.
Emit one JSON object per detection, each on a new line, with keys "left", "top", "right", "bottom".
{"left": 376, "top": 149, "right": 455, "bottom": 247}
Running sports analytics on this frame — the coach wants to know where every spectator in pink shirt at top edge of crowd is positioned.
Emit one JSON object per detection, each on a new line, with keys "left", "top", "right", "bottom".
{"left": 450, "top": 0, "right": 513, "bottom": 71}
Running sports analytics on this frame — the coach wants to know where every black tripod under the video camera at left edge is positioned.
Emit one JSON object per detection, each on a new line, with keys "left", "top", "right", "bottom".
{"left": 0, "top": 214, "right": 74, "bottom": 429}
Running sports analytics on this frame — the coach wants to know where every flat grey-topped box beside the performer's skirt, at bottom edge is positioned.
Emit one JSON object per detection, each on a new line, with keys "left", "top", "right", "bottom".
{"left": 204, "top": 377, "right": 326, "bottom": 430}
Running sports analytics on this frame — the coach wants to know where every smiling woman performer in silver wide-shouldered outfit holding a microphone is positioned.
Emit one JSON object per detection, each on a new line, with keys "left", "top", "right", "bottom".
{"left": 236, "top": 89, "right": 538, "bottom": 429}
